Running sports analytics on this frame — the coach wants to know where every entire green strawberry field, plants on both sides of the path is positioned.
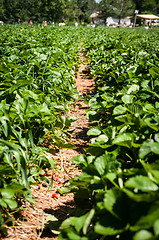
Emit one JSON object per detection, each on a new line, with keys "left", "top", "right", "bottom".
{"left": 0, "top": 26, "right": 159, "bottom": 240}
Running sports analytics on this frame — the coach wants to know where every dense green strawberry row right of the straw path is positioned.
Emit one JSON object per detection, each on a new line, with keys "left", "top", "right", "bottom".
{"left": 56, "top": 28, "right": 159, "bottom": 240}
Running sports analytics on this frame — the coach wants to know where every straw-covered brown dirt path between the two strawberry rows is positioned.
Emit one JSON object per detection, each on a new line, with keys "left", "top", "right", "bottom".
{"left": 5, "top": 47, "right": 94, "bottom": 240}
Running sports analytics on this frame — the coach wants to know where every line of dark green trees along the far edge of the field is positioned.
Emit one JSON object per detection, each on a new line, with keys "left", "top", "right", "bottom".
{"left": 0, "top": 0, "right": 159, "bottom": 23}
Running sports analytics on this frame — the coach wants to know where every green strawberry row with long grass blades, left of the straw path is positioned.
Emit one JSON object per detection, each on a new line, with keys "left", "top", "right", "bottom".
{"left": 0, "top": 25, "right": 80, "bottom": 235}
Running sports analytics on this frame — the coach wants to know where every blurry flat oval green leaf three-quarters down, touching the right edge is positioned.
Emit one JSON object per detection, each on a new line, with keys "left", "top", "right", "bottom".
{"left": 125, "top": 175, "right": 158, "bottom": 192}
